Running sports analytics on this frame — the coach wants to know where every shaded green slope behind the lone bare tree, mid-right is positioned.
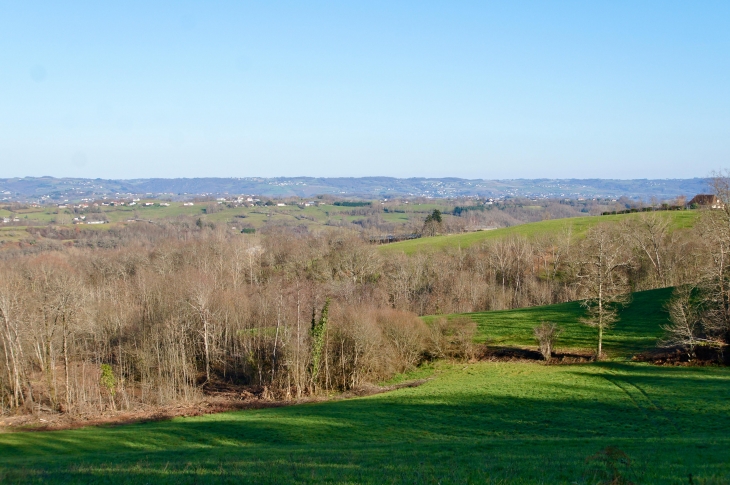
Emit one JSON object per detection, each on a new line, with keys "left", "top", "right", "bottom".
{"left": 426, "top": 288, "right": 672, "bottom": 358}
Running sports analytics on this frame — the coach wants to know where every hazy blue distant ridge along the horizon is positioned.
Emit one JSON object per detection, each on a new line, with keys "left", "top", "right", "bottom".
{"left": 0, "top": 177, "right": 708, "bottom": 200}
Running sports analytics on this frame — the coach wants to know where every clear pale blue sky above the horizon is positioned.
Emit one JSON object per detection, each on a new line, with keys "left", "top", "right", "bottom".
{"left": 0, "top": 0, "right": 730, "bottom": 179}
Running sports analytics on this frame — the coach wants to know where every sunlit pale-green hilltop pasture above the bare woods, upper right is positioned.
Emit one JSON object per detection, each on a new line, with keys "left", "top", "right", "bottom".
{"left": 378, "top": 210, "right": 701, "bottom": 254}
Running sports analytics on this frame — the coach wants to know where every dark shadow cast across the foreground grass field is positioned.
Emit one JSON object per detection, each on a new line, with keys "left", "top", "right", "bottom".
{"left": 0, "top": 395, "right": 730, "bottom": 483}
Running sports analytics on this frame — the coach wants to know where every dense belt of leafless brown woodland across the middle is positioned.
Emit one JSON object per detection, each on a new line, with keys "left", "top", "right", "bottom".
{"left": 0, "top": 206, "right": 700, "bottom": 414}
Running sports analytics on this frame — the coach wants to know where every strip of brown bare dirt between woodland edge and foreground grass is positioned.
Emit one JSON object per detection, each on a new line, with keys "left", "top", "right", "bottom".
{"left": 0, "top": 379, "right": 429, "bottom": 432}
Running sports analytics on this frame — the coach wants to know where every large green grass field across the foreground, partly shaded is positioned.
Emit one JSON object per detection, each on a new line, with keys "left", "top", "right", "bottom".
{"left": 0, "top": 362, "right": 730, "bottom": 484}
